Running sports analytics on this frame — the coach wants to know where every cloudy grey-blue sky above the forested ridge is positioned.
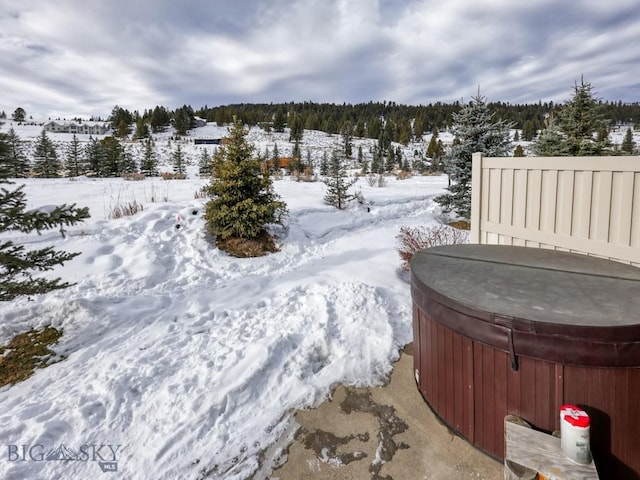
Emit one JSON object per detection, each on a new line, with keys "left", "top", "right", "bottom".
{"left": 0, "top": 0, "right": 640, "bottom": 118}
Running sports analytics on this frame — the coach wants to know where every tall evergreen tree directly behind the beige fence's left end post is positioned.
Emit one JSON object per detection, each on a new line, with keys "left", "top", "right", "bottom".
{"left": 435, "top": 93, "right": 512, "bottom": 220}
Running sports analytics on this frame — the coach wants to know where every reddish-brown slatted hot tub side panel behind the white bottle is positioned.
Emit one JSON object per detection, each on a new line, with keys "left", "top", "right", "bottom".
{"left": 564, "top": 365, "right": 640, "bottom": 479}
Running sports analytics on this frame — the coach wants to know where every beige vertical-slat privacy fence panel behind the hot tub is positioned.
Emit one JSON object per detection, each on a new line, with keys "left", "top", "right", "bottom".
{"left": 471, "top": 153, "right": 640, "bottom": 266}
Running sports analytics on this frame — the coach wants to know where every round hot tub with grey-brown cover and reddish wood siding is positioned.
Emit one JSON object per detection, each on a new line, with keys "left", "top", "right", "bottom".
{"left": 411, "top": 245, "right": 640, "bottom": 480}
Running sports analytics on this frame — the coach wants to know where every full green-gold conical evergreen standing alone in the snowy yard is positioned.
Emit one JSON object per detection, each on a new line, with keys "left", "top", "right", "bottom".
{"left": 204, "top": 119, "right": 287, "bottom": 253}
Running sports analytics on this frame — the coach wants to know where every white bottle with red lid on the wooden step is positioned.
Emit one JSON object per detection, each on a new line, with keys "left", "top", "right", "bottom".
{"left": 560, "top": 405, "right": 591, "bottom": 465}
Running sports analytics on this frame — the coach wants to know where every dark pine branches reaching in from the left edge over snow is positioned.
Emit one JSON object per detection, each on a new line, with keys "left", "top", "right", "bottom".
{"left": 0, "top": 134, "right": 89, "bottom": 301}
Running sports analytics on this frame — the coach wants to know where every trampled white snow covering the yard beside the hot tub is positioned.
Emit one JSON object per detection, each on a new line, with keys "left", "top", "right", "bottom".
{"left": 0, "top": 172, "right": 446, "bottom": 479}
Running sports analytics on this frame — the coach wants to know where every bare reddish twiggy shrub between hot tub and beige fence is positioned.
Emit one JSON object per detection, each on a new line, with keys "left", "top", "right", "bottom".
{"left": 396, "top": 225, "right": 469, "bottom": 270}
